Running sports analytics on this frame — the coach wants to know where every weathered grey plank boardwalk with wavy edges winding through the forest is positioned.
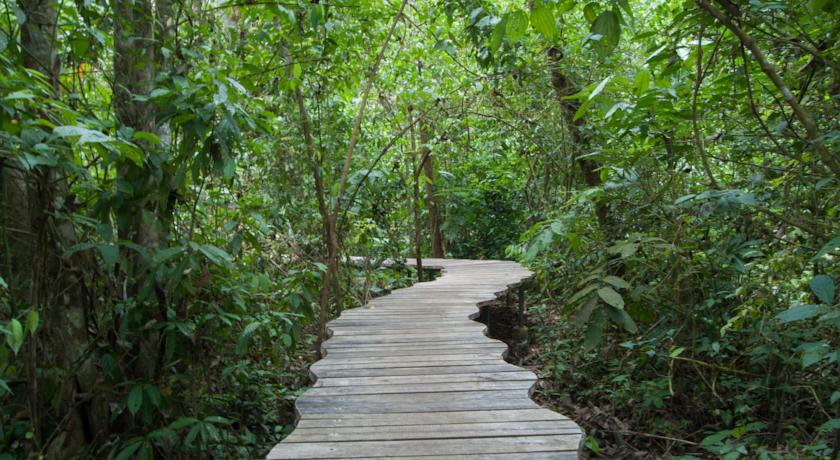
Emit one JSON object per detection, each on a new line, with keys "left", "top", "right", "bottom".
{"left": 268, "top": 259, "right": 581, "bottom": 459}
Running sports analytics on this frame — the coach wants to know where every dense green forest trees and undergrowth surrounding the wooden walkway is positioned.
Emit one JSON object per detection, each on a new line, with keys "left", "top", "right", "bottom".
{"left": 0, "top": 0, "right": 840, "bottom": 459}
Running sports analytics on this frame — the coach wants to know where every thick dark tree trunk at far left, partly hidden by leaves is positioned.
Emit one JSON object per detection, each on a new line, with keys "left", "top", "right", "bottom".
{"left": 0, "top": 0, "right": 108, "bottom": 458}
